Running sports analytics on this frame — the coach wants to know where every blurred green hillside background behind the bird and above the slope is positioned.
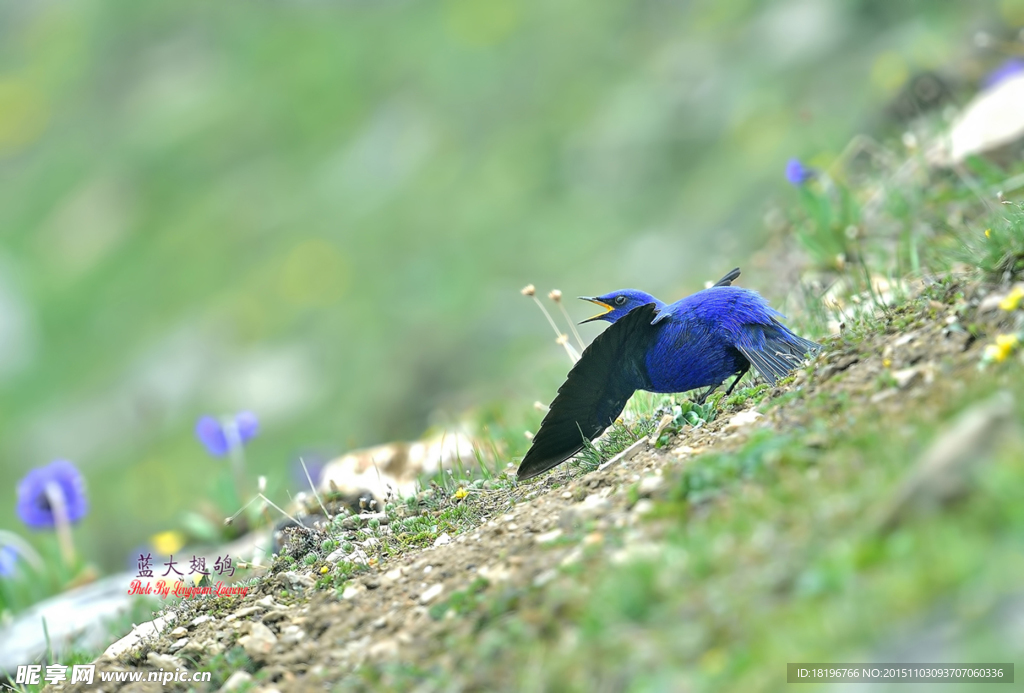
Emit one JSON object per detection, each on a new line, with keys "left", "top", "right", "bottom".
{"left": 0, "top": 0, "right": 1011, "bottom": 569}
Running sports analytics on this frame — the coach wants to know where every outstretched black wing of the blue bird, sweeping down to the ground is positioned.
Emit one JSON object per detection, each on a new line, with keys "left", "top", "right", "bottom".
{"left": 517, "top": 303, "right": 658, "bottom": 480}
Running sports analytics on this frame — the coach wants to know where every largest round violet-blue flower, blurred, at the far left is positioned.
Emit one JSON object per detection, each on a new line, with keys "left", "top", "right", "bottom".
{"left": 17, "top": 460, "right": 89, "bottom": 529}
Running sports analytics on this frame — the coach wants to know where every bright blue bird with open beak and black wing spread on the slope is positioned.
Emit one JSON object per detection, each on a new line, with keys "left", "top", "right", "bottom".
{"left": 517, "top": 268, "right": 821, "bottom": 480}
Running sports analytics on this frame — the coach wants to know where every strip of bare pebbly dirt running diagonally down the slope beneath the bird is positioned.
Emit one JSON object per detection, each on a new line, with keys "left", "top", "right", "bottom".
{"left": 41, "top": 272, "right": 1015, "bottom": 693}
